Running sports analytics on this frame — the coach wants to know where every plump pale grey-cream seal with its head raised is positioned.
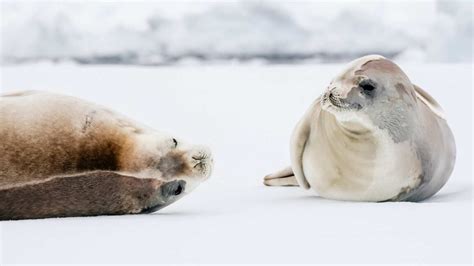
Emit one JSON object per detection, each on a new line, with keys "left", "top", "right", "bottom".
{"left": 264, "top": 55, "right": 456, "bottom": 201}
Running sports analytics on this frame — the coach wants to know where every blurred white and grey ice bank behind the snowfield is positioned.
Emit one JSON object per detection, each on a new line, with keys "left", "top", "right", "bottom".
{"left": 1, "top": 1, "right": 473, "bottom": 65}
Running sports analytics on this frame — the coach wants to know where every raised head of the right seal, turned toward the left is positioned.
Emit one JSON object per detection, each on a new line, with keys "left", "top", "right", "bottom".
{"left": 321, "top": 56, "right": 418, "bottom": 143}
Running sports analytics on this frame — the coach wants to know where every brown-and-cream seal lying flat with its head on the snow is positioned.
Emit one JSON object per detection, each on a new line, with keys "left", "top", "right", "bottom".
{"left": 0, "top": 92, "right": 212, "bottom": 220}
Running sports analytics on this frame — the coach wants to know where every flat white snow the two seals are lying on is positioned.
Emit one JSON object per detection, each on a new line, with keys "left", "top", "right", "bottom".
{"left": 0, "top": 63, "right": 472, "bottom": 264}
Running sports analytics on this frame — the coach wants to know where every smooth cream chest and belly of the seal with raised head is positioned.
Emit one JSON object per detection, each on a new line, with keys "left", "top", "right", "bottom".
{"left": 303, "top": 113, "right": 421, "bottom": 201}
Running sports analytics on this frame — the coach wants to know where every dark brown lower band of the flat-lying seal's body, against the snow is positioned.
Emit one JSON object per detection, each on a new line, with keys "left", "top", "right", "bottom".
{"left": 0, "top": 171, "right": 166, "bottom": 220}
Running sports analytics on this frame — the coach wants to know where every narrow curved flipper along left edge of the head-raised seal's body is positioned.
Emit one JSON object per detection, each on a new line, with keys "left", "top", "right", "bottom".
{"left": 290, "top": 97, "right": 321, "bottom": 189}
